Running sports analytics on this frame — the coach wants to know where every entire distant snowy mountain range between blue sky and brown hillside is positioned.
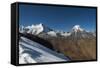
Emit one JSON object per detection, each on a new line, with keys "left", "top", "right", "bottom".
{"left": 19, "top": 23, "right": 96, "bottom": 38}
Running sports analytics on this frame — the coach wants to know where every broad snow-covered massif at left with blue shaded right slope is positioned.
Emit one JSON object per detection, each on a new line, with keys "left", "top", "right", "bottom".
{"left": 20, "top": 23, "right": 52, "bottom": 35}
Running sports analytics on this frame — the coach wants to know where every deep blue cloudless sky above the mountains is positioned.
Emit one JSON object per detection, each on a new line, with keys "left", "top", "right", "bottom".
{"left": 19, "top": 4, "right": 96, "bottom": 31}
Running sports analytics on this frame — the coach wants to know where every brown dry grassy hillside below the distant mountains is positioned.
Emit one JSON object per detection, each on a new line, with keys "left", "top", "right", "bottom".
{"left": 38, "top": 37, "right": 96, "bottom": 61}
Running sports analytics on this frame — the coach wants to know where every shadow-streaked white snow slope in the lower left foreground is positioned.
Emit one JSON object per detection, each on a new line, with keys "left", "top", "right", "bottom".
{"left": 19, "top": 36, "right": 69, "bottom": 64}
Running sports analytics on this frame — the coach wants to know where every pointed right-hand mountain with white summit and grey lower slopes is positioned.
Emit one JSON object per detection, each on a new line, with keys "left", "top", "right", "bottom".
{"left": 70, "top": 25, "right": 95, "bottom": 39}
